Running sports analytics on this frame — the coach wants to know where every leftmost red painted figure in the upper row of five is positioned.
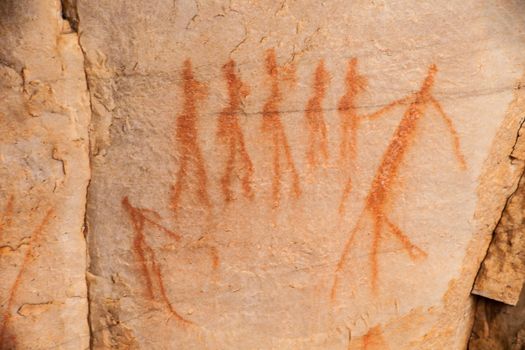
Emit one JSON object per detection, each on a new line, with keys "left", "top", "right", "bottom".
{"left": 171, "top": 60, "right": 211, "bottom": 213}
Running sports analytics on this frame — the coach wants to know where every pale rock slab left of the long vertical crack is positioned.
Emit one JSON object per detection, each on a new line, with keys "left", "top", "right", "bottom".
{"left": 0, "top": 0, "right": 90, "bottom": 349}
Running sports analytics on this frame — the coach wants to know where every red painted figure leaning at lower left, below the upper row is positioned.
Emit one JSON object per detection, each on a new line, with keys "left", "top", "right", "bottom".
{"left": 122, "top": 197, "right": 193, "bottom": 325}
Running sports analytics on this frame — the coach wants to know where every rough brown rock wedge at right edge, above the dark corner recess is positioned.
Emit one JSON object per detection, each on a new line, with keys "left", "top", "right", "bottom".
{"left": 473, "top": 160, "right": 525, "bottom": 305}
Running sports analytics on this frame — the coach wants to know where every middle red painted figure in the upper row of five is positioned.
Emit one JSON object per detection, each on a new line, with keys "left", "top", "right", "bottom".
{"left": 262, "top": 49, "right": 301, "bottom": 208}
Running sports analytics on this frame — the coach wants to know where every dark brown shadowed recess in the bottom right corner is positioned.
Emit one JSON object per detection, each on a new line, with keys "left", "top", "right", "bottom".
{"left": 469, "top": 284, "right": 525, "bottom": 350}
